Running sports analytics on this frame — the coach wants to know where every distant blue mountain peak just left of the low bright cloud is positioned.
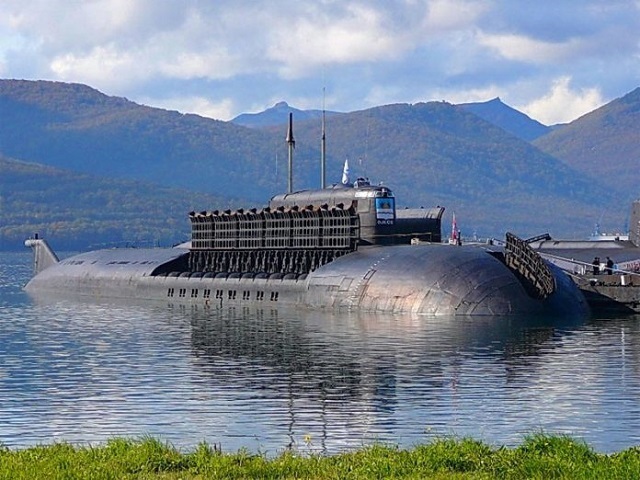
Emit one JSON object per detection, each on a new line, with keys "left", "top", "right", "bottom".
{"left": 458, "top": 97, "right": 551, "bottom": 142}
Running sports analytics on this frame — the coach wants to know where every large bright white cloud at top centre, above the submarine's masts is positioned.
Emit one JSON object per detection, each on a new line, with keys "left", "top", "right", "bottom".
{"left": 266, "top": 0, "right": 487, "bottom": 78}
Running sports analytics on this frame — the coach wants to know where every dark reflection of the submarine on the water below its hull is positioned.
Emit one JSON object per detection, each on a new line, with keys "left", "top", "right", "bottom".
{"left": 190, "top": 308, "right": 576, "bottom": 394}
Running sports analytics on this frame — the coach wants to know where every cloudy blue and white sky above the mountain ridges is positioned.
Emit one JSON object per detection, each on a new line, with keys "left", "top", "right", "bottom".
{"left": 0, "top": 0, "right": 640, "bottom": 125}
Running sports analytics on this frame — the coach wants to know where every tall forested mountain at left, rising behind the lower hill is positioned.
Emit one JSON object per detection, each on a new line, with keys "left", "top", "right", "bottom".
{"left": 0, "top": 80, "right": 294, "bottom": 200}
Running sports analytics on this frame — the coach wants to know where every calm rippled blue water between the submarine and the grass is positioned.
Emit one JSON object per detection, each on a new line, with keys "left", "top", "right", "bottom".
{"left": 0, "top": 252, "right": 640, "bottom": 454}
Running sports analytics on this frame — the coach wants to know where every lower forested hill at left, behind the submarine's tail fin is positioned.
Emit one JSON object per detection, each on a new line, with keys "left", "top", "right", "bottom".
{"left": 0, "top": 156, "right": 242, "bottom": 250}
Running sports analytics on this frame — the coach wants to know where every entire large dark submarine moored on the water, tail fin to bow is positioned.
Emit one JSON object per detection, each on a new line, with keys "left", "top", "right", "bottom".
{"left": 25, "top": 116, "right": 588, "bottom": 316}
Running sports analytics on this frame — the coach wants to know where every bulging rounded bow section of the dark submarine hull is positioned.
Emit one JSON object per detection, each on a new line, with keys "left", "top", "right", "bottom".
{"left": 306, "top": 244, "right": 588, "bottom": 316}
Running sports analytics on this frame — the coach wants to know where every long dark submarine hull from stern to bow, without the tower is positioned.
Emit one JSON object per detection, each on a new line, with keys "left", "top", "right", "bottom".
{"left": 25, "top": 240, "right": 588, "bottom": 315}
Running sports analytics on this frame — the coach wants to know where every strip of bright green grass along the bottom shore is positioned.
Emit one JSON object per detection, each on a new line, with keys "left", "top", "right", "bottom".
{"left": 0, "top": 434, "right": 640, "bottom": 480}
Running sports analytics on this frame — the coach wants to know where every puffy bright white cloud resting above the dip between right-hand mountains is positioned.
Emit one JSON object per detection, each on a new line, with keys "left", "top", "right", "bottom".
{"left": 516, "top": 76, "right": 605, "bottom": 125}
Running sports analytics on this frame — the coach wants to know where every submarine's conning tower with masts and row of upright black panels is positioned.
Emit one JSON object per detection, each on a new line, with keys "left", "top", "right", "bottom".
{"left": 189, "top": 114, "right": 444, "bottom": 277}
